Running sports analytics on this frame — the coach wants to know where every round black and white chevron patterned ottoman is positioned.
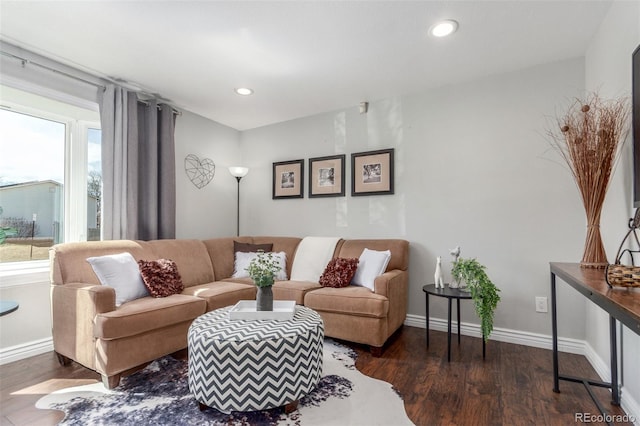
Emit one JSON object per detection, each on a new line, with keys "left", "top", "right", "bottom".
{"left": 187, "top": 306, "right": 324, "bottom": 413}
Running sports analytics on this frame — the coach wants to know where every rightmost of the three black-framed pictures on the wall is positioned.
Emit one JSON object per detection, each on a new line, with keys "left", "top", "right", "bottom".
{"left": 351, "top": 148, "right": 393, "bottom": 196}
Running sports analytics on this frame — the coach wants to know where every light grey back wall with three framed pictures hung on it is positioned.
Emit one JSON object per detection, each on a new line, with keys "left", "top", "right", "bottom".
{"left": 241, "top": 59, "right": 585, "bottom": 339}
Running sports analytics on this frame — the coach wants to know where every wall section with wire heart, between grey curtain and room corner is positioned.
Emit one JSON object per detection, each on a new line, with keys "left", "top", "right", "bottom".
{"left": 175, "top": 111, "right": 244, "bottom": 239}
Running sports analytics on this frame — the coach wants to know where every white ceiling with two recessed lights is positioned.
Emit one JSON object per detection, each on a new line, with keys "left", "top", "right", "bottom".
{"left": 0, "top": 0, "right": 611, "bottom": 130}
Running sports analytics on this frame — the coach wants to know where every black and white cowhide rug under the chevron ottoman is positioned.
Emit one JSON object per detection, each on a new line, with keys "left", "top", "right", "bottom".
{"left": 36, "top": 339, "right": 413, "bottom": 426}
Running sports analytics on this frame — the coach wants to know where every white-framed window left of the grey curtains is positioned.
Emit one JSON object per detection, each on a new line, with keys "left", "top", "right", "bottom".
{"left": 0, "top": 87, "right": 102, "bottom": 263}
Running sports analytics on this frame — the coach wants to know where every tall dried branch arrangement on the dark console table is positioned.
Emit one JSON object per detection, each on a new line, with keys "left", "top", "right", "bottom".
{"left": 548, "top": 93, "right": 630, "bottom": 268}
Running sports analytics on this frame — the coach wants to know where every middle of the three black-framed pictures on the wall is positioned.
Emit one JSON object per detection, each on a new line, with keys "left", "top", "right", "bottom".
{"left": 309, "top": 154, "right": 346, "bottom": 198}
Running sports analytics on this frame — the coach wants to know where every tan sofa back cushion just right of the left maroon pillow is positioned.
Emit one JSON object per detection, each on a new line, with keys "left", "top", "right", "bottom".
{"left": 147, "top": 240, "right": 215, "bottom": 287}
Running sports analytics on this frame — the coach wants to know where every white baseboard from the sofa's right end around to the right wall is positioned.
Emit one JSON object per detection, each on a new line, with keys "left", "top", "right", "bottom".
{"left": 404, "top": 314, "right": 640, "bottom": 426}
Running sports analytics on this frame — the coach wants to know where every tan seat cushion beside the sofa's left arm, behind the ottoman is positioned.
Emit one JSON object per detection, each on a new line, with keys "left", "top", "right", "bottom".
{"left": 93, "top": 294, "right": 207, "bottom": 340}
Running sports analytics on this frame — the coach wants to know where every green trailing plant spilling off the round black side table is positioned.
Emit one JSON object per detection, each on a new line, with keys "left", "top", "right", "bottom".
{"left": 451, "top": 258, "right": 500, "bottom": 341}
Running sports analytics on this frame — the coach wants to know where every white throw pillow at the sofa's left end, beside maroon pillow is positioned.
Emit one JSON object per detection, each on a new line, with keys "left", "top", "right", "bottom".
{"left": 87, "top": 253, "right": 149, "bottom": 306}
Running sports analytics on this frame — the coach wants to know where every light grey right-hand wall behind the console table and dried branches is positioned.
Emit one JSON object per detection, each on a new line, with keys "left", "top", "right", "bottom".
{"left": 585, "top": 1, "right": 640, "bottom": 420}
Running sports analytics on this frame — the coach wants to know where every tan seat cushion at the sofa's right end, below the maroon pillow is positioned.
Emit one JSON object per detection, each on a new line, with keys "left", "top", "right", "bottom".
{"left": 304, "top": 286, "right": 389, "bottom": 318}
